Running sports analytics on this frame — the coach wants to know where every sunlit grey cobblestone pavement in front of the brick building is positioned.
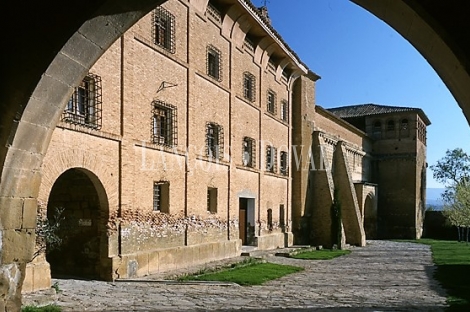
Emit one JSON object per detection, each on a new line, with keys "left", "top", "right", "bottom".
{"left": 23, "top": 241, "right": 446, "bottom": 311}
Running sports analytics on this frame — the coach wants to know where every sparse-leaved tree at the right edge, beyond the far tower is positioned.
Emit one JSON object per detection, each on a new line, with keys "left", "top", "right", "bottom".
{"left": 431, "top": 148, "right": 470, "bottom": 242}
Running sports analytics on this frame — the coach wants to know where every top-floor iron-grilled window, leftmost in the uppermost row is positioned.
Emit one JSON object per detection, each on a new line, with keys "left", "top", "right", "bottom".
{"left": 152, "top": 7, "right": 175, "bottom": 53}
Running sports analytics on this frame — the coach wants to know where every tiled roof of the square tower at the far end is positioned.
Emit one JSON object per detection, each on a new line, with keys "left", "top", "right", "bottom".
{"left": 327, "top": 103, "right": 431, "bottom": 125}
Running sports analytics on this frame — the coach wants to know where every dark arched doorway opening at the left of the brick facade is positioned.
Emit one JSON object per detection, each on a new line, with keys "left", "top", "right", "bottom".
{"left": 46, "top": 168, "right": 109, "bottom": 279}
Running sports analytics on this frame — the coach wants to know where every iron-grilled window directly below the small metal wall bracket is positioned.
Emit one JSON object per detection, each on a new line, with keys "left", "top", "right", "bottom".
{"left": 152, "top": 100, "right": 178, "bottom": 147}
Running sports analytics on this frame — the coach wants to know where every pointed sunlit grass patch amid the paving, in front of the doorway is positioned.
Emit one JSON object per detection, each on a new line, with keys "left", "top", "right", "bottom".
{"left": 179, "top": 258, "right": 303, "bottom": 286}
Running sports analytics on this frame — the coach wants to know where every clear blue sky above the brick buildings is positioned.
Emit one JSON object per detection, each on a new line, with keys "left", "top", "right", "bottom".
{"left": 252, "top": 0, "right": 470, "bottom": 188}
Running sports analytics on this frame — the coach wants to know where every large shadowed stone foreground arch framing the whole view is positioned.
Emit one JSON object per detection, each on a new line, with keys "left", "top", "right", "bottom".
{"left": 0, "top": 0, "right": 470, "bottom": 310}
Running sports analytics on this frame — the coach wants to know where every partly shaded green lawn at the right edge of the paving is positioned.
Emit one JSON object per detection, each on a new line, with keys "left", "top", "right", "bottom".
{"left": 398, "top": 239, "right": 470, "bottom": 311}
